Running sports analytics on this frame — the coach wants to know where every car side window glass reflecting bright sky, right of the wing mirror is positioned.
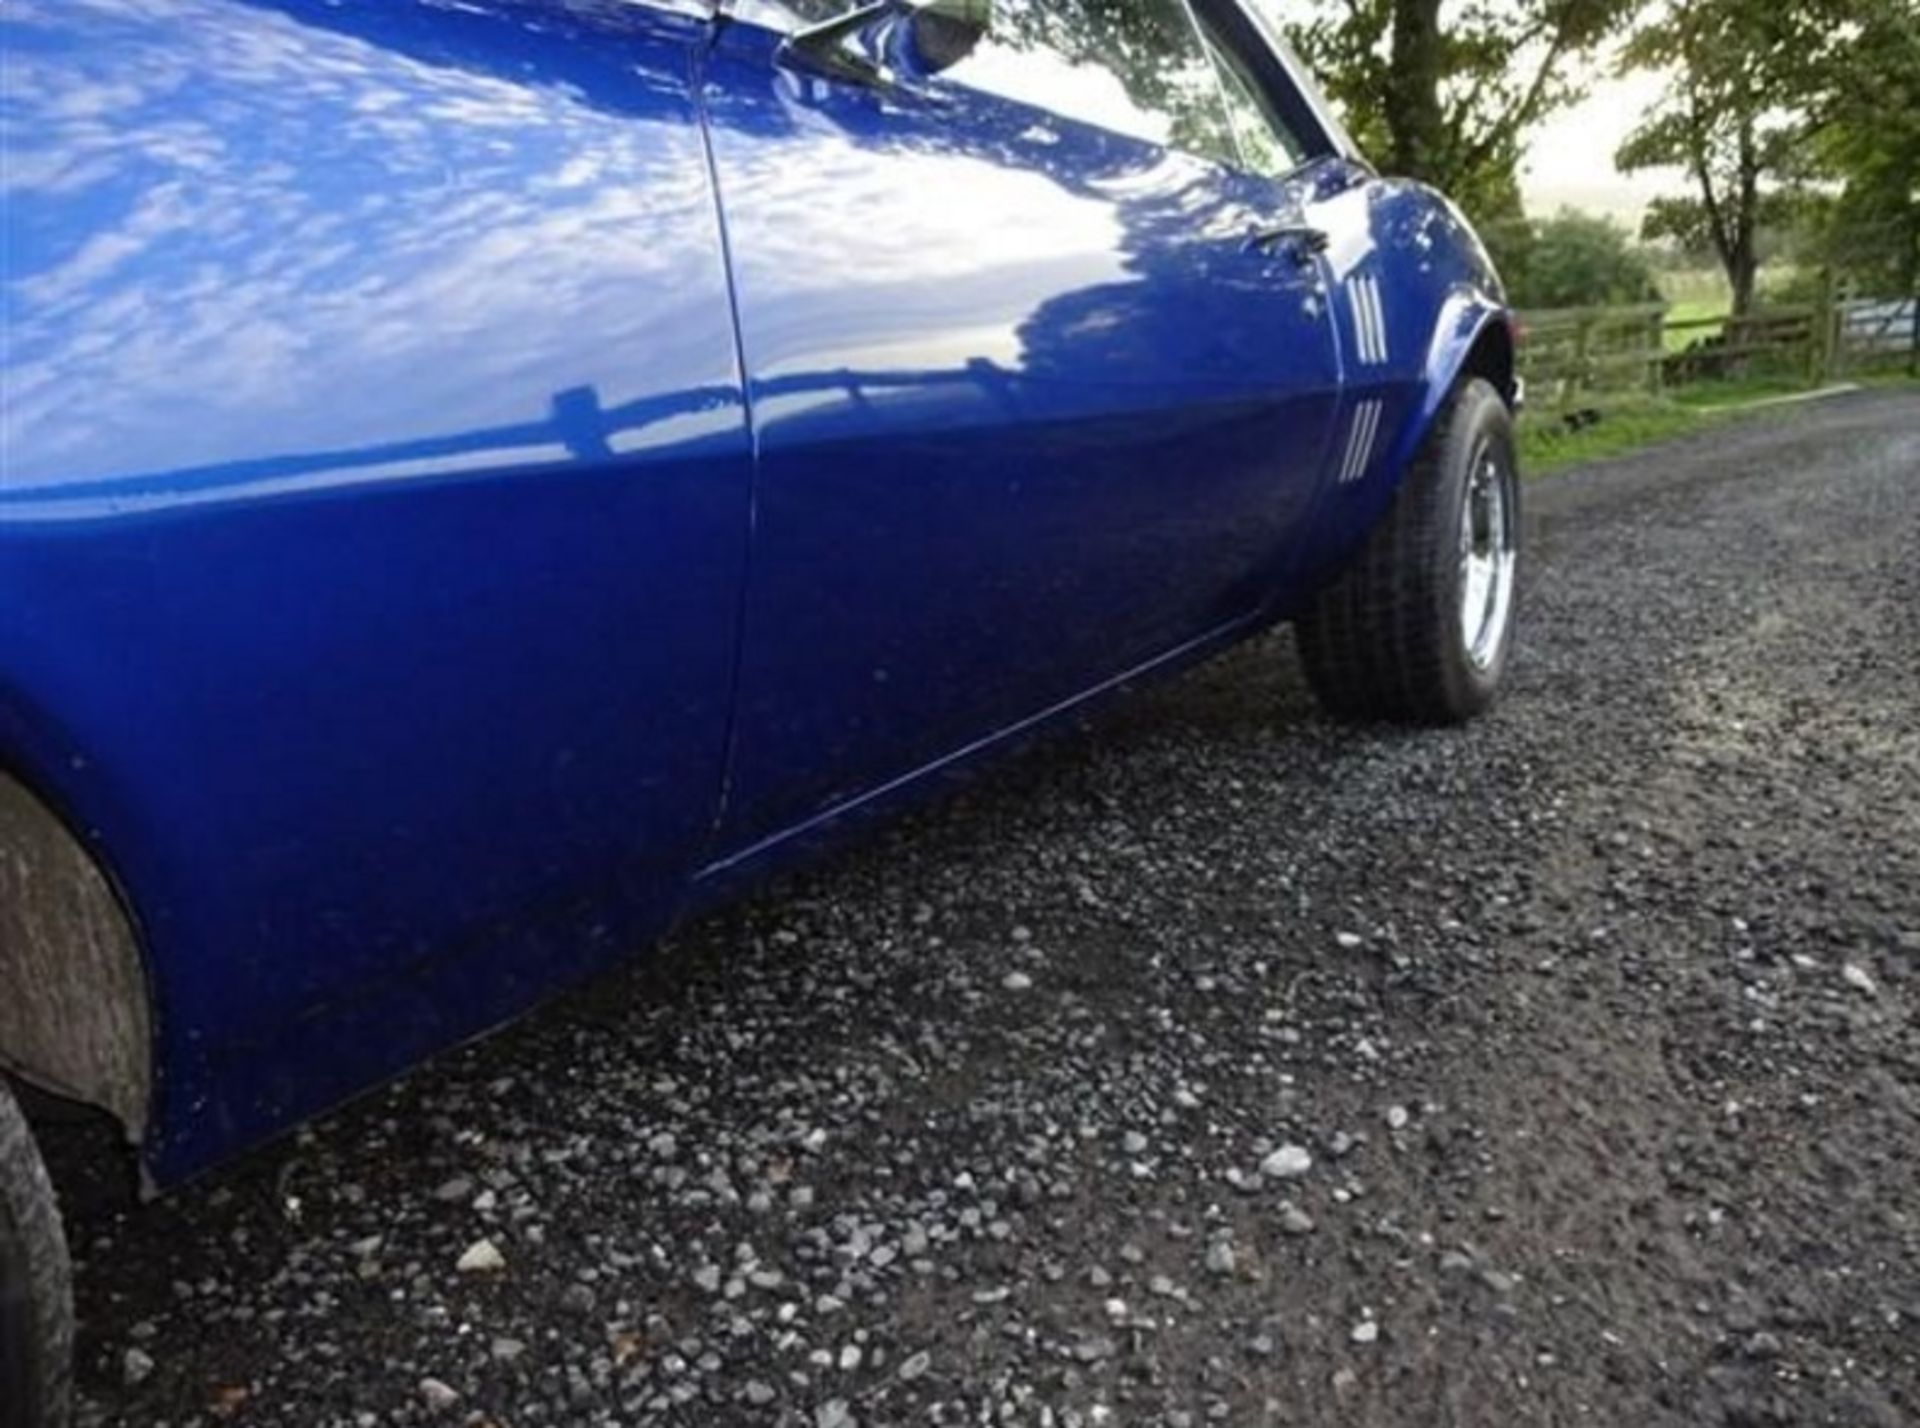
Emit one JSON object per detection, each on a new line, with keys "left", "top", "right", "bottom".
{"left": 947, "top": 0, "right": 1238, "bottom": 163}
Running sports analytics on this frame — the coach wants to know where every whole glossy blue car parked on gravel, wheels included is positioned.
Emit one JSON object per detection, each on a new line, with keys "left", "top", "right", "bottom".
{"left": 0, "top": 0, "right": 1519, "bottom": 1428}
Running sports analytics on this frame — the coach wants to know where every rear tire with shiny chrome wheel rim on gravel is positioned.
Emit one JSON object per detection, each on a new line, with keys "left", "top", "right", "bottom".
{"left": 1294, "top": 376, "right": 1521, "bottom": 724}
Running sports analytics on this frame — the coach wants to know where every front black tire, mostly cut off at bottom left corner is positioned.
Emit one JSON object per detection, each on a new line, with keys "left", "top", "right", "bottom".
{"left": 0, "top": 1079, "right": 73, "bottom": 1428}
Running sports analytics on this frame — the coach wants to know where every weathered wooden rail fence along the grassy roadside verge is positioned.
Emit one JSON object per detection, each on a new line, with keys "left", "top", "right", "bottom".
{"left": 1521, "top": 287, "right": 1920, "bottom": 409}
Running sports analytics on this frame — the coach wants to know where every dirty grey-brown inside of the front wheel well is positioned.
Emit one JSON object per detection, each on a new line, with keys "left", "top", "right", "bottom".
{"left": 0, "top": 770, "right": 154, "bottom": 1142}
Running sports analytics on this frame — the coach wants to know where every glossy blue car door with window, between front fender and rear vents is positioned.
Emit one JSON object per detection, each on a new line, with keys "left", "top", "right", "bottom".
{"left": 705, "top": 0, "right": 1338, "bottom": 852}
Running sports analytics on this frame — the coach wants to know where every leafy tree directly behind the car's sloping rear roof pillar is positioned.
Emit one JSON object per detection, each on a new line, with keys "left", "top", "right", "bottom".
{"left": 1256, "top": 0, "right": 1634, "bottom": 221}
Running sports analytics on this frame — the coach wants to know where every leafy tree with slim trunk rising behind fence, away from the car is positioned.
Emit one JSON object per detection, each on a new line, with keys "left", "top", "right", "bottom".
{"left": 1615, "top": 0, "right": 1850, "bottom": 315}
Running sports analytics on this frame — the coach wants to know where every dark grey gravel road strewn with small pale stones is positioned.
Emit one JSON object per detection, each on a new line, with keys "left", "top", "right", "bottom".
{"left": 52, "top": 392, "right": 1920, "bottom": 1428}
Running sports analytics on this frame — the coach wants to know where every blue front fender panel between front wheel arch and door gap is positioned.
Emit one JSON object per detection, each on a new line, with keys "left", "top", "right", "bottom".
{"left": 0, "top": 0, "right": 751, "bottom": 1178}
